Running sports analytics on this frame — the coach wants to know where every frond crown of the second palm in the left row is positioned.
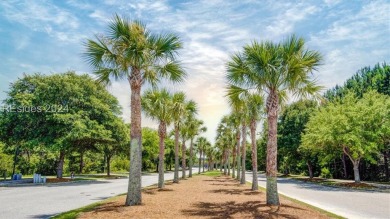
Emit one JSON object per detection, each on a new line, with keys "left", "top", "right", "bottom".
{"left": 141, "top": 89, "right": 173, "bottom": 124}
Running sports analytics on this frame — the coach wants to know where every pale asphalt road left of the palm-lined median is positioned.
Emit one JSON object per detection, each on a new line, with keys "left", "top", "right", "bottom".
{"left": 0, "top": 169, "right": 198, "bottom": 219}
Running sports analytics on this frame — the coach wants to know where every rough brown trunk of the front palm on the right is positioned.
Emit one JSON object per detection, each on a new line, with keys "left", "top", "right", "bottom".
{"left": 266, "top": 90, "right": 280, "bottom": 205}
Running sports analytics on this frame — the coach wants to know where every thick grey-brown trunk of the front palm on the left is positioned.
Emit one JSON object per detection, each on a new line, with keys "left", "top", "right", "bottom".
{"left": 125, "top": 71, "right": 142, "bottom": 206}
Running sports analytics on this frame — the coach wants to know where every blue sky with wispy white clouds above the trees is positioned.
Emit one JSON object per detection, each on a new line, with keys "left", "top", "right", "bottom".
{"left": 0, "top": 0, "right": 390, "bottom": 140}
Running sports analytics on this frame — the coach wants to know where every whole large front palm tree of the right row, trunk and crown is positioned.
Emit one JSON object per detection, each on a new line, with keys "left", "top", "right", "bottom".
{"left": 227, "top": 35, "right": 322, "bottom": 205}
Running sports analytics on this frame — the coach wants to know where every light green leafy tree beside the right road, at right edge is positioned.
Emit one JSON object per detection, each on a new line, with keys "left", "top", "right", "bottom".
{"left": 302, "top": 91, "right": 390, "bottom": 183}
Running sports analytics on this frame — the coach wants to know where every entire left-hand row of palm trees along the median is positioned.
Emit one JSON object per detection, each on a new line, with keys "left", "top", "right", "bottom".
{"left": 84, "top": 15, "right": 206, "bottom": 205}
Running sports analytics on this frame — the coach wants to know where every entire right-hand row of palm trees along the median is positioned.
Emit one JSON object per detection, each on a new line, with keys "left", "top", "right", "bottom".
{"left": 222, "top": 35, "right": 322, "bottom": 205}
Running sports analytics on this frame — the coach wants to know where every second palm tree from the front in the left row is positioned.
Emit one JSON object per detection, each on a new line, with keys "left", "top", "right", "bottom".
{"left": 142, "top": 89, "right": 173, "bottom": 189}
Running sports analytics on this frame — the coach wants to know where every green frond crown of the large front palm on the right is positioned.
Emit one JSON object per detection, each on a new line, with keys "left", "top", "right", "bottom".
{"left": 227, "top": 35, "right": 322, "bottom": 97}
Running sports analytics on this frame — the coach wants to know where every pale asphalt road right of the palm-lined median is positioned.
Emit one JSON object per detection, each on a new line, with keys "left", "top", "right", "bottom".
{"left": 246, "top": 173, "right": 390, "bottom": 219}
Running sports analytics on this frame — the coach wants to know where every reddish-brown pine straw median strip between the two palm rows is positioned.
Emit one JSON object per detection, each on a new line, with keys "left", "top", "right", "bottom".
{"left": 68, "top": 175, "right": 336, "bottom": 219}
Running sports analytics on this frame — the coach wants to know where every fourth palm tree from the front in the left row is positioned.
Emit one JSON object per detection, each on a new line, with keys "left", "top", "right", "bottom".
{"left": 187, "top": 117, "right": 207, "bottom": 177}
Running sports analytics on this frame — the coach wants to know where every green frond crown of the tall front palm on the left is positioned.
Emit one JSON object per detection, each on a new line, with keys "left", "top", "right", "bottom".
{"left": 84, "top": 15, "right": 186, "bottom": 85}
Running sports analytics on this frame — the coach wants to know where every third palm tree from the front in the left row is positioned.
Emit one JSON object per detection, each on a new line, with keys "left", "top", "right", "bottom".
{"left": 171, "top": 92, "right": 197, "bottom": 183}
